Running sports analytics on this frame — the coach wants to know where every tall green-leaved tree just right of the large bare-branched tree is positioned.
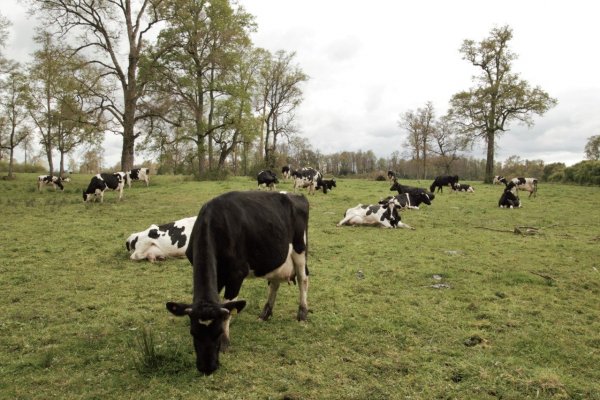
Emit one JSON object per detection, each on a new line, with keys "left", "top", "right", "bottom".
{"left": 148, "top": 0, "right": 254, "bottom": 176}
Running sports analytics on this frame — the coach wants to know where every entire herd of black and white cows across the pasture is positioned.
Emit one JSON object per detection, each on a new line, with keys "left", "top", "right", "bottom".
{"left": 38, "top": 163, "right": 537, "bottom": 375}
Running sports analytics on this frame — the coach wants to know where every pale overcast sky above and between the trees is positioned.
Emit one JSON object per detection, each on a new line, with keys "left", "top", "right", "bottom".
{"left": 0, "top": 0, "right": 600, "bottom": 165}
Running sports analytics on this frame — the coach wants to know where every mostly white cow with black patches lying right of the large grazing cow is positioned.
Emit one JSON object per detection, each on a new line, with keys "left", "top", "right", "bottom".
{"left": 337, "top": 196, "right": 414, "bottom": 229}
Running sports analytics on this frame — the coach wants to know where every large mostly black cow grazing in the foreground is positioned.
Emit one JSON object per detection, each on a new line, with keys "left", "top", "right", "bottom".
{"left": 166, "top": 191, "right": 309, "bottom": 375}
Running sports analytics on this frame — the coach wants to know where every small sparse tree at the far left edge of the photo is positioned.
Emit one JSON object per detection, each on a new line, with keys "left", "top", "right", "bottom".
{"left": 0, "top": 62, "right": 30, "bottom": 178}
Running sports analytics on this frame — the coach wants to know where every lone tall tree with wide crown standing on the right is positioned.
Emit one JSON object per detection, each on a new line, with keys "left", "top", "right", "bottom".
{"left": 449, "top": 26, "right": 557, "bottom": 183}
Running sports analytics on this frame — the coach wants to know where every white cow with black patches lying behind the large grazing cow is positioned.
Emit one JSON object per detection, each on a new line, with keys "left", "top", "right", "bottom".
{"left": 125, "top": 217, "right": 197, "bottom": 262}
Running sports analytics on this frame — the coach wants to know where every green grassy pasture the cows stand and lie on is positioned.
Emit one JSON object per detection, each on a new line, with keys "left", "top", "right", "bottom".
{"left": 0, "top": 174, "right": 600, "bottom": 400}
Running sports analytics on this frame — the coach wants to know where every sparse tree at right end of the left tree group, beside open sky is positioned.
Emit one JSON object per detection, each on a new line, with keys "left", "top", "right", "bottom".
{"left": 258, "top": 50, "right": 308, "bottom": 168}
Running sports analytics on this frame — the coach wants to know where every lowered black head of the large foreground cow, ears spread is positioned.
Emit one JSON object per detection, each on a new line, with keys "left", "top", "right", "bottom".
{"left": 167, "top": 300, "right": 246, "bottom": 375}
